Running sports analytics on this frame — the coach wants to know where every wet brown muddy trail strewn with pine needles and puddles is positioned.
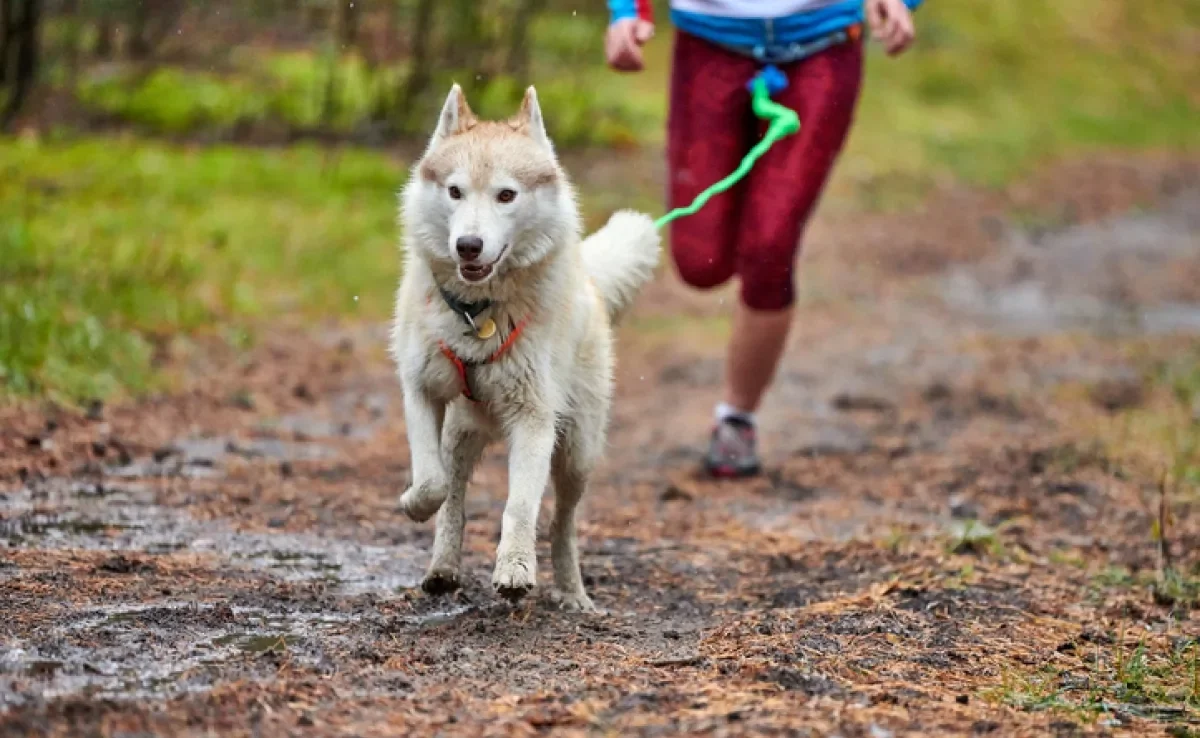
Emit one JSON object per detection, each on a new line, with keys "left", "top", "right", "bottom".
{"left": 0, "top": 154, "right": 1200, "bottom": 737}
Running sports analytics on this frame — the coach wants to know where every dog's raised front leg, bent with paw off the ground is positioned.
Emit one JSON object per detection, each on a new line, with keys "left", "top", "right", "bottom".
{"left": 400, "top": 386, "right": 448, "bottom": 522}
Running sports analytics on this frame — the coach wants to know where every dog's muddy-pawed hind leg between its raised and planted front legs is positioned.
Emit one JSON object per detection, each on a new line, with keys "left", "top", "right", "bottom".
{"left": 421, "top": 404, "right": 487, "bottom": 594}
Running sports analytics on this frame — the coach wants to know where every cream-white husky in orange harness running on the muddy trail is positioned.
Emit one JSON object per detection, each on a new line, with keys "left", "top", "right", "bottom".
{"left": 391, "top": 85, "right": 659, "bottom": 611}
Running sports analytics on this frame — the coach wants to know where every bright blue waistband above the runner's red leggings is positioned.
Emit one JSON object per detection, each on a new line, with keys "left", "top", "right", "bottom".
{"left": 671, "top": 0, "right": 922, "bottom": 57}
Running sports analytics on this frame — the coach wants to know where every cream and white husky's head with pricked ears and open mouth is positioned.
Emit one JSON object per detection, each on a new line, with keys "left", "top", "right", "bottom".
{"left": 404, "top": 85, "right": 578, "bottom": 286}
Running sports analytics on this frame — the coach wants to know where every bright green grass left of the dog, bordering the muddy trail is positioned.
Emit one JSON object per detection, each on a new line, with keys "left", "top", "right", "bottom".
{"left": 0, "top": 135, "right": 403, "bottom": 400}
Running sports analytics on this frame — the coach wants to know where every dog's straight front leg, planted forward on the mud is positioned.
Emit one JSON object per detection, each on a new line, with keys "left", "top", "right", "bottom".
{"left": 492, "top": 413, "right": 554, "bottom": 600}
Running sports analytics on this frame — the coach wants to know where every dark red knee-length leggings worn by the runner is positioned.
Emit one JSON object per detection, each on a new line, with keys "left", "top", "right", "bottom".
{"left": 667, "top": 32, "right": 863, "bottom": 311}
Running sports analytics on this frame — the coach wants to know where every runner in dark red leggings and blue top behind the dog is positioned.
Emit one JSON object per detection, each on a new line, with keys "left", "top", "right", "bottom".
{"left": 605, "top": 0, "right": 922, "bottom": 476}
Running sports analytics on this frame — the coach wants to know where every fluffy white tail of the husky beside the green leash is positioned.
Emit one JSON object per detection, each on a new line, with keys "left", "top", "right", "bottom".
{"left": 582, "top": 210, "right": 660, "bottom": 324}
